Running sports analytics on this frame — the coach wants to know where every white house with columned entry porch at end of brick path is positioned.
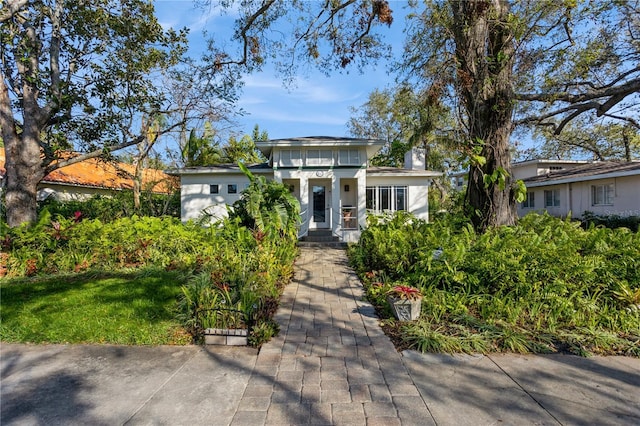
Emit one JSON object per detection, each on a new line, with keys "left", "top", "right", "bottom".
{"left": 169, "top": 137, "right": 442, "bottom": 241}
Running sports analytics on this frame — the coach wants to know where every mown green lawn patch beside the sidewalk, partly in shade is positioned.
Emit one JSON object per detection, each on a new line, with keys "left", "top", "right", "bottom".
{"left": 0, "top": 268, "right": 191, "bottom": 345}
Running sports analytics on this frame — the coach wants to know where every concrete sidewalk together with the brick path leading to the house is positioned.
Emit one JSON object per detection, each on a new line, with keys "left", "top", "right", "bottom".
{"left": 0, "top": 247, "right": 640, "bottom": 425}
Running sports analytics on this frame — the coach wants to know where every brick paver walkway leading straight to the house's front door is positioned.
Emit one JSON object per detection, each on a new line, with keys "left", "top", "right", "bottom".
{"left": 233, "top": 247, "right": 434, "bottom": 425}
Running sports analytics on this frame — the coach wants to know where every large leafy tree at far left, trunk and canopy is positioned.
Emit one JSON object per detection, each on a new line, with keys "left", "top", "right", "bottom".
{"left": 0, "top": 0, "right": 184, "bottom": 227}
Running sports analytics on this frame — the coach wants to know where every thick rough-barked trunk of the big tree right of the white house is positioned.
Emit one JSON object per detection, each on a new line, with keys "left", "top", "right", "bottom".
{"left": 451, "top": 0, "right": 517, "bottom": 231}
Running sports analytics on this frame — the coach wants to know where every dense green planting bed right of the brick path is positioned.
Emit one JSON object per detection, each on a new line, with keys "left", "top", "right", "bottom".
{"left": 349, "top": 213, "right": 640, "bottom": 356}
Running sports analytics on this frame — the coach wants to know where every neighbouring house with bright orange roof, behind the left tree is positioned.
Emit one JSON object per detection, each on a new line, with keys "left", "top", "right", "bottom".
{"left": 0, "top": 148, "right": 176, "bottom": 201}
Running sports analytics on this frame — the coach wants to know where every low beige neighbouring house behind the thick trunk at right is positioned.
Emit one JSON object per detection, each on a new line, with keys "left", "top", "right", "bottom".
{"left": 514, "top": 161, "right": 640, "bottom": 218}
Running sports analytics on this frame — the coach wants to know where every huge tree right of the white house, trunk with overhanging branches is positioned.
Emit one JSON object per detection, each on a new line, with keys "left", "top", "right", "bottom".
{"left": 208, "top": 0, "right": 640, "bottom": 230}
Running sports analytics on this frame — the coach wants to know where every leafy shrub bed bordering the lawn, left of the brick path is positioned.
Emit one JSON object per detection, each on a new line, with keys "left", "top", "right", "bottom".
{"left": 0, "top": 206, "right": 297, "bottom": 346}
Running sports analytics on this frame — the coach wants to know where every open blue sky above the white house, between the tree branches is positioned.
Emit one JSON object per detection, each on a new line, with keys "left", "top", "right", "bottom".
{"left": 155, "top": 0, "right": 404, "bottom": 139}
